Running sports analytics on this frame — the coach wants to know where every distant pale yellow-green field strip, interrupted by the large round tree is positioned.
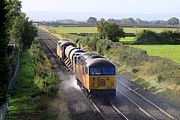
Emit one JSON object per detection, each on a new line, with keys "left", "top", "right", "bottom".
{"left": 47, "top": 27, "right": 177, "bottom": 33}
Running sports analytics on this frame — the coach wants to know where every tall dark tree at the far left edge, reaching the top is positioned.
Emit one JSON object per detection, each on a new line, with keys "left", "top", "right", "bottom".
{"left": 0, "top": 0, "right": 33, "bottom": 105}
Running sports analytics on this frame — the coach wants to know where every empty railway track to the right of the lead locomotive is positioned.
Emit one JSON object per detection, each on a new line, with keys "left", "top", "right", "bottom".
{"left": 117, "top": 80, "right": 177, "bottom": 120}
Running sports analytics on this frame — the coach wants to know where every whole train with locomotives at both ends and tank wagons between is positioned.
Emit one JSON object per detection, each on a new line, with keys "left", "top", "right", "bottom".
{"left": 56, "top": 41, "right": 116, "bottom": 97}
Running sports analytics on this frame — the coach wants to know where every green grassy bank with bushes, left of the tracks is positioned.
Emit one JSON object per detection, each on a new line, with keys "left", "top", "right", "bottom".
{"left": 7, "top": 41, "right": 69, "bottom": 120}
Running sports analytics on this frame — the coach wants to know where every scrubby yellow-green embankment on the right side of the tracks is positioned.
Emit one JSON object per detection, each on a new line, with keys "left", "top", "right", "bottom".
{"left": 43, "top": 28, "right": 180, "bottom": 107}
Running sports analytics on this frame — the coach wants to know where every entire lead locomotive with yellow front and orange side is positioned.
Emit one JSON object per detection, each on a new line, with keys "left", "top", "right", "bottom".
{"left": 76, "top": 53, "right": 116, "bottom": 96}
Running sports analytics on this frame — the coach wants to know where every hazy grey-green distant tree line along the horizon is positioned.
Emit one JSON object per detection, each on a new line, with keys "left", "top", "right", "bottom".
{"left": 38, "top": 17, "right": 179, "bottom": 27}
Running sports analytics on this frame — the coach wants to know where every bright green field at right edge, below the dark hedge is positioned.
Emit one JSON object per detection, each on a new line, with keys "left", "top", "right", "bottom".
{"left": 131, "top": 45, "right": 180, "bottom": 63}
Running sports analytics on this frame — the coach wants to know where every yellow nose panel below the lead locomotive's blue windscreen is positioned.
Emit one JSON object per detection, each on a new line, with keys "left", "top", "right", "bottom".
{"left": 89, "top": 75, "right": 116, "bottom": 89}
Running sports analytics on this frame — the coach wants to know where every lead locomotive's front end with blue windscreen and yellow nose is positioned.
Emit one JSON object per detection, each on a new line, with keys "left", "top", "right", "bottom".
{"left": 87, "top": 58, "right": 116, "bottom": 96}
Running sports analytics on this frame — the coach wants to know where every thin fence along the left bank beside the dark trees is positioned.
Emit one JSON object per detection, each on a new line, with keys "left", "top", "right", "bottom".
{"left": 0, "top": 50, "right": 20, "bottom": 120}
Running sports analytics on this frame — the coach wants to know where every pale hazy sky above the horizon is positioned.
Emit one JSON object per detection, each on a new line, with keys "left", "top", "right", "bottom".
{"left": 21, "top": 0, "right": 180, "bottom": 20}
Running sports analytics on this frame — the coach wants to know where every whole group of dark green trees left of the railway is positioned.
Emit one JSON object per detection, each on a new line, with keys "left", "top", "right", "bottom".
{"left": 0, "top": 0, "right": 37, "bottom": 106}
